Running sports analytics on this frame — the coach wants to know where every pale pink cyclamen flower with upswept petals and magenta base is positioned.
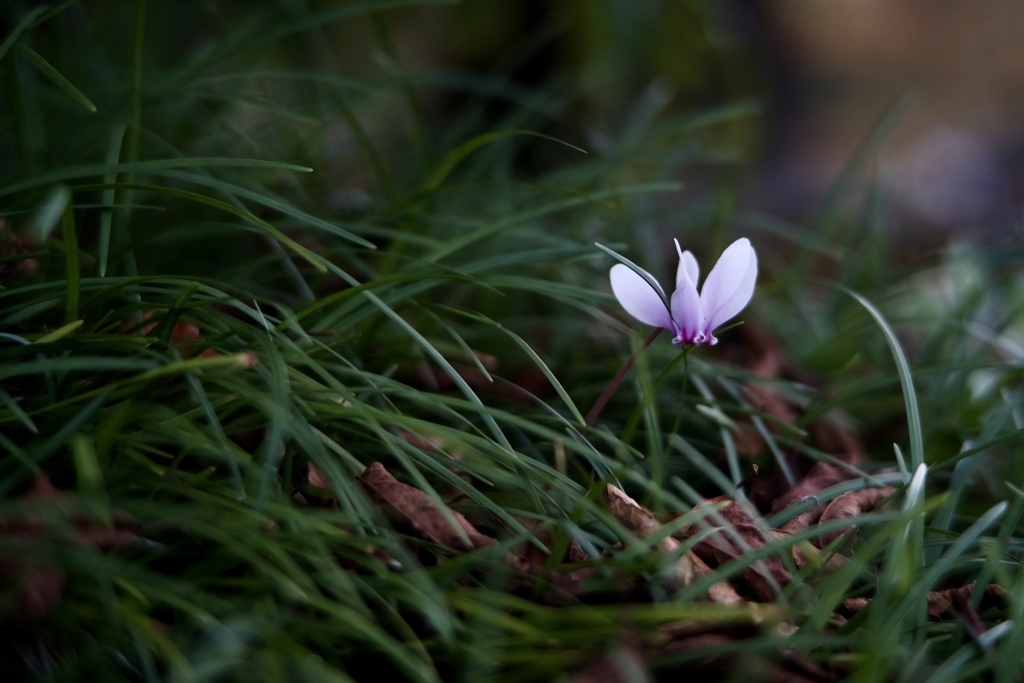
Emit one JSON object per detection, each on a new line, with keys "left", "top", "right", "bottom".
{"left": 609, "top": 238, "right": 758, "bottom": 344}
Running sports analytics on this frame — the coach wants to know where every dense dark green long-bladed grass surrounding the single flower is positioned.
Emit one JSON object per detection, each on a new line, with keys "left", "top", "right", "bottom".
{"left": 0, "top": 0, "right": 1024, "bottom": 681}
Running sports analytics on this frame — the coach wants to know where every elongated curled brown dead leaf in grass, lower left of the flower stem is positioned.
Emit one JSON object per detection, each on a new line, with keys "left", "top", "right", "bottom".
{"left": 359, "top": 463, "right": 498, "bottom": 550}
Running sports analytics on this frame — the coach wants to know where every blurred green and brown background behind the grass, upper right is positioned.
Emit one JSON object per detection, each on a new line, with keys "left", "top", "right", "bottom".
{"left": 315, "top": 0, "right": 1024, "bottom": 244}
